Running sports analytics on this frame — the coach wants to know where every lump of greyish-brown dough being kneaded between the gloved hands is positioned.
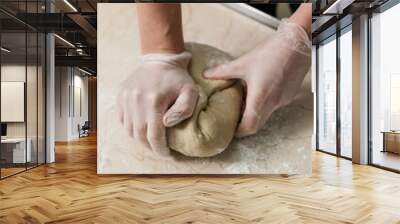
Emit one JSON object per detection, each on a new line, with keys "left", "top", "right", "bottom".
{"left": 167, "top": 43, "right": 243, "bottom": 157}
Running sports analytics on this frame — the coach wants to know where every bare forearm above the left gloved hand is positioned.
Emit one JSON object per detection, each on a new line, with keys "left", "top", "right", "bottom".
{"left": 137, "top": 3, "right": 184, "bottom": 54}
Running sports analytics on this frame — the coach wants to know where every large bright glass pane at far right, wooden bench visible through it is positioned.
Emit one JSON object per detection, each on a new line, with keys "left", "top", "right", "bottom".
{"left": 371, "top": 4, "right": 400, "bottom": 170}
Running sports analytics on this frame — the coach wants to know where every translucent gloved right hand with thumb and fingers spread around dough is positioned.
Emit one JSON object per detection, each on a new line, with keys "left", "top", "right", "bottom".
{"left": 204, "top": 20, "right": 311, "bottom": 137}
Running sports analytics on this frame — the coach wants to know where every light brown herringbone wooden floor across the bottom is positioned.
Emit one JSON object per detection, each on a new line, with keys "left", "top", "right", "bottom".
{"left": 0, "top": 134, "right": 400, "bottom": 224}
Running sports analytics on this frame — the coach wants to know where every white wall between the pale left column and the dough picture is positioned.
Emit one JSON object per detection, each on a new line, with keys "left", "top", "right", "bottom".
{"left": 55, "top": 67, "right": 88, "bottom": 141}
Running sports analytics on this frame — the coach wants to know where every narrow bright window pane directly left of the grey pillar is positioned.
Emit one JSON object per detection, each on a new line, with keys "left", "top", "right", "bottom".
{"left": 340, "top": 30, "right": 353, "bottom": 158}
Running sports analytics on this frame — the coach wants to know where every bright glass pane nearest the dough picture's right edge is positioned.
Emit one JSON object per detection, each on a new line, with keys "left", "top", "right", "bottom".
{"left": 318, "top": 38, "right": 336, "bottom": 153}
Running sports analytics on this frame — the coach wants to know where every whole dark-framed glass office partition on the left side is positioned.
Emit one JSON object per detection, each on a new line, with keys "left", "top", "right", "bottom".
{"left": 0, "top": 1, "right": 46, "bottom": 178}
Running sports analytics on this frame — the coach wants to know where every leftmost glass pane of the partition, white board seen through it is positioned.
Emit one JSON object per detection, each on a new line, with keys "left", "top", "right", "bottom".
{"left": 0, "top": 32, "right": 27, "bottom": 178}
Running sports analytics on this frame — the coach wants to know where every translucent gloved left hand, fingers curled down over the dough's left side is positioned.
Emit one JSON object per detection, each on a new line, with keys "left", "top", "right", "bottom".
{"left": 117, "top": 52, "right": 198, "bottom": 155}
